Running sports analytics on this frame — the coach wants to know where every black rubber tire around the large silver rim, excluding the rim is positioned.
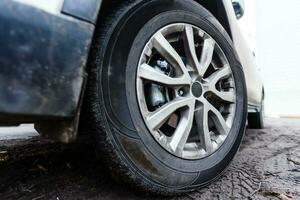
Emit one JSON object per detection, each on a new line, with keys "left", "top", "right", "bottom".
{"left": 83, "top": 0, "right": 247, "bottom": 195}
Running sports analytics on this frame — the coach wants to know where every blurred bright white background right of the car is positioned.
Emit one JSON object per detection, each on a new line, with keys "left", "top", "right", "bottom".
{"left": 239, "top": 0, "right": 300, "bottom": 118}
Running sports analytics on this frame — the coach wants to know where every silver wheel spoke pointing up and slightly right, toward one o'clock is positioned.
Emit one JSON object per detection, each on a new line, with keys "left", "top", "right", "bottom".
{"left": 199, "top": 38, "right": 215, "bottom": 77}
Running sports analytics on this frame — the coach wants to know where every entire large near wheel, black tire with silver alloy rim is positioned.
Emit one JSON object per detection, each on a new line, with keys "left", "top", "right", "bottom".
{"left": 84, "top": 0, "right": 247, "bottom": 195}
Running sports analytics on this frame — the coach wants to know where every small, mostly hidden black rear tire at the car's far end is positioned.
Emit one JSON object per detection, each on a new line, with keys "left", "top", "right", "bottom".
{"left": 248, "top": 98, "right": 265, "bottom": 129}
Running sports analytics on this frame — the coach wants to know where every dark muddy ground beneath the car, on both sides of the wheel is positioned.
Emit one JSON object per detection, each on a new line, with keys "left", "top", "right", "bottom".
{"left": 0, "top": 119, "right": 300, "bottom": 200}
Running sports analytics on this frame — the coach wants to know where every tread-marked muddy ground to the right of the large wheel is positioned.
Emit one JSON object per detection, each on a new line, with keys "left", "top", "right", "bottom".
{"left": 179, "top": 119, "right": 300, "bottom": 199}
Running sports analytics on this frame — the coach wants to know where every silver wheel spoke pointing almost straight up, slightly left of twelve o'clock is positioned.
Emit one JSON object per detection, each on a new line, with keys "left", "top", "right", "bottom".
{"left": 184, "top": 25, "right": 201, "bottom": 73}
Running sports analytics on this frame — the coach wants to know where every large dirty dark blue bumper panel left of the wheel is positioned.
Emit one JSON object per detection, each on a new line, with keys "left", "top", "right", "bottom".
{"left": 0, "top": 0, "right": 94, "bottom": 122}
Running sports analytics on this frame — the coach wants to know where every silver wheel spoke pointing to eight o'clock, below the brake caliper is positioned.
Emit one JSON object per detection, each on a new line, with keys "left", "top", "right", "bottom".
{"left": 147, "top": 98, "right": 192, "bottom": 130}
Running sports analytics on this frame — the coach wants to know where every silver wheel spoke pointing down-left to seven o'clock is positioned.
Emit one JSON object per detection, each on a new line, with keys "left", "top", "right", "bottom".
{"left": 169, "top": 100, "right": 195, "bottom": 156}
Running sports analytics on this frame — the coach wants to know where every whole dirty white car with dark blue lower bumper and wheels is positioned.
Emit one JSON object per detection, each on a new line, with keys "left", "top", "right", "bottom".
{"left": 0, "top": 0, "right": 264, "bottom": 195}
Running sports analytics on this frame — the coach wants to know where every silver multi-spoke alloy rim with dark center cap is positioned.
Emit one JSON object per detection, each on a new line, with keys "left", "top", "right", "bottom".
{"left": 136, "top": 23, "right": 236, "bottom": 159}
